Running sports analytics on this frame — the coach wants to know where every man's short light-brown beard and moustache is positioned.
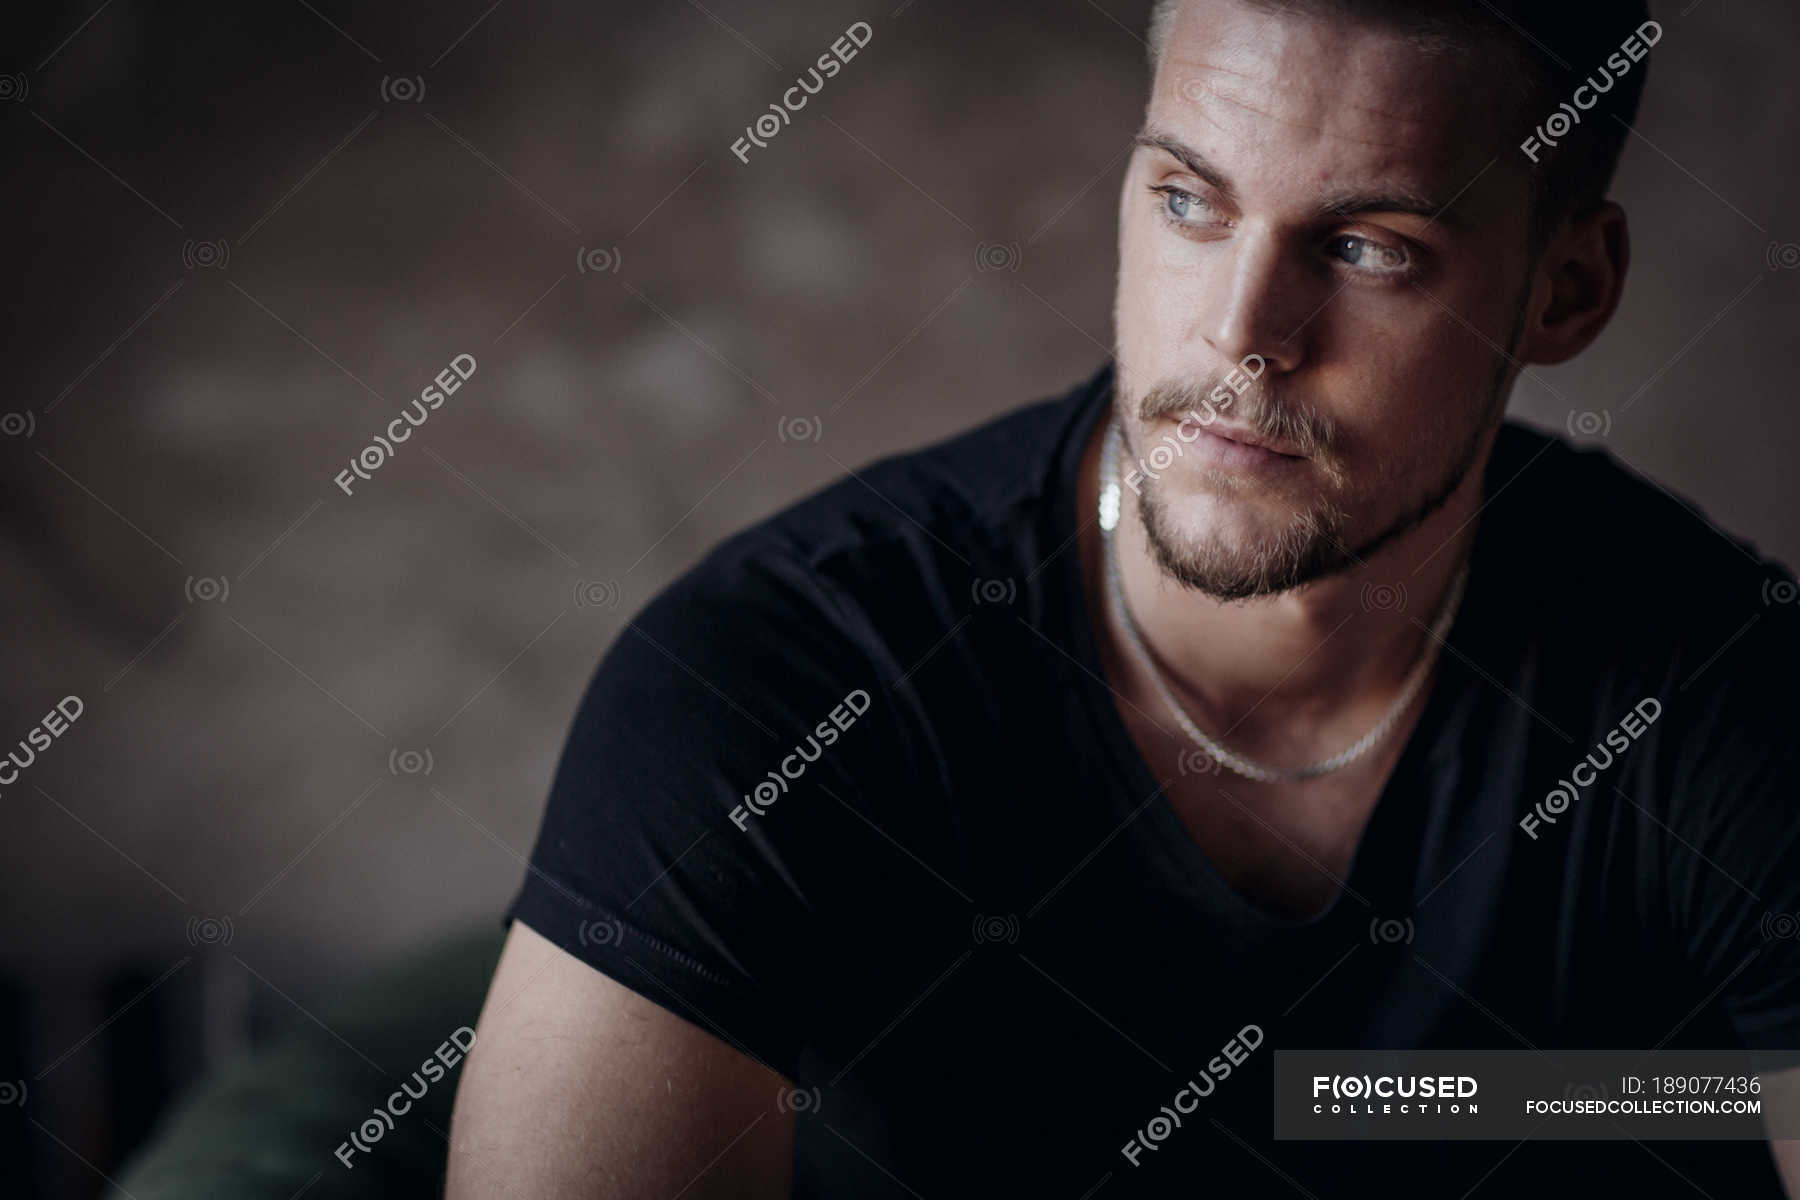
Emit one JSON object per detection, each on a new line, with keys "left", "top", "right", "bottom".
{"left": 1112, "top": 299, "right": 1525, "bottom": 601}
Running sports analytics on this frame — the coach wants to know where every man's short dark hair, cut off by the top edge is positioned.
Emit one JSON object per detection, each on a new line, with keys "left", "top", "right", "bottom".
{"left": 1148, "top": 0, "right": 1651, "bottom": 250}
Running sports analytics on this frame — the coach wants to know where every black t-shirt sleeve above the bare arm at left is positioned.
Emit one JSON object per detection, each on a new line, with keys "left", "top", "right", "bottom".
{"left": 504, "top": 534, "right": 896, "bottom": 1079}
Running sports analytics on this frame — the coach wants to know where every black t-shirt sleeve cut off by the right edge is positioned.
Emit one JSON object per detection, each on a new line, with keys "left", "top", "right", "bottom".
{"left": 1667, "top": 606, "right": 1800, "bottom": 1051}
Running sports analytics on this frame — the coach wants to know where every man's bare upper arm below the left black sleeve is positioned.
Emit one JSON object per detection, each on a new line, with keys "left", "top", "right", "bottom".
{"left": 445, "top": 921, "right": 794, "bottom": 1200}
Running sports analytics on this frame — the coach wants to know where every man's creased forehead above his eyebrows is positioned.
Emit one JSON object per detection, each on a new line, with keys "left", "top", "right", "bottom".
{"left": 1147, "top": 0, "right": 1510, "bottom": 189}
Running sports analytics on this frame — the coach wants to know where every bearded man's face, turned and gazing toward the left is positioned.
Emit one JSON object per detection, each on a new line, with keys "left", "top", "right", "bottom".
{"left": 1114, "top": 0, "right": 1530, "bottom": 599}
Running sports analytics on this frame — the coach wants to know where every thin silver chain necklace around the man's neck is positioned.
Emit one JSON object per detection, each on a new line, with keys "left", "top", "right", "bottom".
{"left": 1100, "top": 419, "right": 1469, "bottom": 783}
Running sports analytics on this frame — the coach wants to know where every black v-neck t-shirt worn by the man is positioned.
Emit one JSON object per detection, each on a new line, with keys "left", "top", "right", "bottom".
{"left": 508, "top": 369, "right": 1800, "bottom": 1200}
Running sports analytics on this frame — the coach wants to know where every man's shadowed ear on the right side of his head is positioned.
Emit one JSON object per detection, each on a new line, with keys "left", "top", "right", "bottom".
{"left": 1519, "top": 200, "right": 1631, "bottom": 363}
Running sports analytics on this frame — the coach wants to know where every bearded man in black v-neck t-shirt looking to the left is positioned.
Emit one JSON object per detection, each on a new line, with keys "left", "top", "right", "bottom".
{"left": 450, "top": 0, "right": 1800, "bottom": 1200}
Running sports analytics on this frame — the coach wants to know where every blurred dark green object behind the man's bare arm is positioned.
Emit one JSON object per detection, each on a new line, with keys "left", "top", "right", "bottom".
{"left": 115, "top": 928, "right": 506, "bottom": 1200}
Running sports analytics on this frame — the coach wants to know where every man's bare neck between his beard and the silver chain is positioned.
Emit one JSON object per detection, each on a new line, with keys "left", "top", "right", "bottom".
{"left": 1076, "top": 402, "right": 1492, "bottom": 745}
